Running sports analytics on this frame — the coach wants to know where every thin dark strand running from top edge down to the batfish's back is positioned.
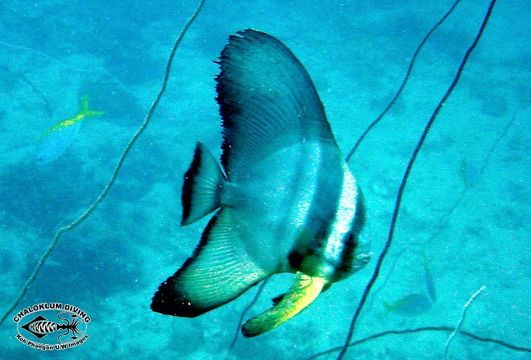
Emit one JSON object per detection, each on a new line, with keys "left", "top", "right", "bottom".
{"left": 345, "top": 0, "right": 461, "bottom": 162}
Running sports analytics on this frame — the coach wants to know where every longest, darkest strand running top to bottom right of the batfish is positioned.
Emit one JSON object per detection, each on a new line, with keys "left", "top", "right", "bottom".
{"left": 337, "top": 0, "right": 496, "bottom": 360}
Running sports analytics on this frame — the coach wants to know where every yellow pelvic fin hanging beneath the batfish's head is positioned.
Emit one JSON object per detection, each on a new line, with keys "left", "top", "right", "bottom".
{"left": 242, "top": 273, "right": 328, "bottom": 337}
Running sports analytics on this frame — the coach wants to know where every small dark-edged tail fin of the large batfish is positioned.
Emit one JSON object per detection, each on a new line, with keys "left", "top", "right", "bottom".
{"left": 181, "top": 143, "right": 225, "bottom": 225}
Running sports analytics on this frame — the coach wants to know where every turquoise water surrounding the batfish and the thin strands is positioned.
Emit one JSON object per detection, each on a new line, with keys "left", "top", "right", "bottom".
{"left": 0, "top": 0, "right": 531, "bottom": 359}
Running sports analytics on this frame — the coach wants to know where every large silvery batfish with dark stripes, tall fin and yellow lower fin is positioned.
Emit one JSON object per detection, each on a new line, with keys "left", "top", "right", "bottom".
{"left": 151, "top": 30, "right": 370, "bottom": 337}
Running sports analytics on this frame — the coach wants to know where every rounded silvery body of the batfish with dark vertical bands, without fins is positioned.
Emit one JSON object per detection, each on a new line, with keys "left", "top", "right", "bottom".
{"left": 222, "top": 142, "right": 364, "bottom": 281}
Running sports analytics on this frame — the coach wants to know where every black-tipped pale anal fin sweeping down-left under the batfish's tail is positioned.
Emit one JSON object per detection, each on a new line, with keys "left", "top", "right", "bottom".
{"left": 151, "top": 209, "right": 270, "bottom": 317}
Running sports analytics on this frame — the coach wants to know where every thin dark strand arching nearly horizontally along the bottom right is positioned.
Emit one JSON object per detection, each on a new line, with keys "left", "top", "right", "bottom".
{"left": 304, "top": 326, "right": 531, "bottom": 360}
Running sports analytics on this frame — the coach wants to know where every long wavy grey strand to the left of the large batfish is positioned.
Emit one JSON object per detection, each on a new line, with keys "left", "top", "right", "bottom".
{"left": 0, "top": 0, "right": 206, "bottom": 325}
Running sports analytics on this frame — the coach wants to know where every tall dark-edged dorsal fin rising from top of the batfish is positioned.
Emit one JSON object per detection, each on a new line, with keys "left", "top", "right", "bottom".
{"left": 216, "top": 30, "right": 335, "bottom": 180}
